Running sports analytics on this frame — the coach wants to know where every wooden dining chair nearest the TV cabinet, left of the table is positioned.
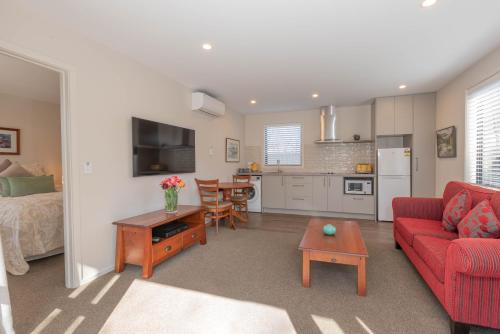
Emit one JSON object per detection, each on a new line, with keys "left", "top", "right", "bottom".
{"left": 195, "top": 179, "right": 235, "bottom": 233}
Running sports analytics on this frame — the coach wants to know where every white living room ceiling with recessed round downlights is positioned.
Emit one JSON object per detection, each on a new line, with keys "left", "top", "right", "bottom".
{"left": 23, "top": 0, "right": 500, "bottom": 112}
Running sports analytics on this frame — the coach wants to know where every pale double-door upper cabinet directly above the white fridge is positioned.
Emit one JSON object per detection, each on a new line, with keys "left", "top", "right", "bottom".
{"left": 375, "top": 95, "right": 413, "bottom": 136}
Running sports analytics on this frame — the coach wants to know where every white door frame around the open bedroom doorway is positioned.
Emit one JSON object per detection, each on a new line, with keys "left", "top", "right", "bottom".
{"left": 0, "top": 40, "right": 82, "bottom": 288}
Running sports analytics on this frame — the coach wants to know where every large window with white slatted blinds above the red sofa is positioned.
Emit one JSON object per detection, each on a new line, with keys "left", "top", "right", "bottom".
{"left": 465, "top": 75, "right": 500, "bottom": 188}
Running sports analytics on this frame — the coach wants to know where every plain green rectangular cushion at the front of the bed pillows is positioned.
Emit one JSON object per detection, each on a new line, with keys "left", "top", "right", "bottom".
{"left": 7, "top": 175, "right": 56, "bottom": 197}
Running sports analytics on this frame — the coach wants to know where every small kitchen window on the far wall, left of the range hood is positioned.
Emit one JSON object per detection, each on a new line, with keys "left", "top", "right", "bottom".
{"left": 264, "top": 124, "right": 302, "bottom": 166}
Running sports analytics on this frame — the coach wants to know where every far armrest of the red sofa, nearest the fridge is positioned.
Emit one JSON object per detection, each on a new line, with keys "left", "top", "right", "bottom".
{"left": 392, "top": 197, "right": 444, "bottom": 220}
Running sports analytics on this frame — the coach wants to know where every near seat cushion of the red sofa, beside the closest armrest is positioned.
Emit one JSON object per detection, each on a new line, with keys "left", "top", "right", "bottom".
{"left": 413, "top": 235, "right": 451, "bottom": 283}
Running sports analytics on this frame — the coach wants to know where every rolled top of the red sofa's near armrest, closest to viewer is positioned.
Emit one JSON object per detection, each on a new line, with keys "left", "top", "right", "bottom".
{"left": 446, "top": 238, "right": 500, "bottom": 278}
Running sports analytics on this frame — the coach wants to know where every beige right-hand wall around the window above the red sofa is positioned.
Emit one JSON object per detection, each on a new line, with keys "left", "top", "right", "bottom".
{"left": 436, "top": 48, "right": 500, "bottom": 196}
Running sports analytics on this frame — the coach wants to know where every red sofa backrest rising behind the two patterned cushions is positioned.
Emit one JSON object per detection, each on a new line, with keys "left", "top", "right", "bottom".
{"left": 443, "top": 181, "right": 500, "bottom": 217}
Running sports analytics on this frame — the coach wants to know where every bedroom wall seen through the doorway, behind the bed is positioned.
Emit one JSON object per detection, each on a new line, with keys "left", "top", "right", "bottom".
{"left": 0, "top": 94, "right": 61, "bottom": 185}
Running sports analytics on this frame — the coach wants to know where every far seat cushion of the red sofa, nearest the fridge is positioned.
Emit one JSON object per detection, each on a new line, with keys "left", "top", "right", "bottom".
{"left": 394, "top": 217, "right": 458, "bottom": 247}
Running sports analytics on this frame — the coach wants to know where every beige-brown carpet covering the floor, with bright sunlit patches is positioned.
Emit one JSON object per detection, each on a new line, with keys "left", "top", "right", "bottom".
{"left": 5, "top": 214, "right": 494, "bottom": 334}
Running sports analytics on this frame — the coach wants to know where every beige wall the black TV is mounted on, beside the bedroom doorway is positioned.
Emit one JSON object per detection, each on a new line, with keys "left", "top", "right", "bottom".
{"left": 0, "top": 1, "right": 244, "bottom": 281}
